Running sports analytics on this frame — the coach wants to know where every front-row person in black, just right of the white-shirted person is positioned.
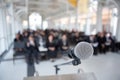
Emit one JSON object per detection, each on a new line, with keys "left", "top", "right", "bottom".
{"left": 46, "top": 34, "right": 57, "bottom": 62}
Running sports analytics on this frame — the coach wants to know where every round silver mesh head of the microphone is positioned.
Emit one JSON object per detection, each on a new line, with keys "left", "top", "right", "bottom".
{"left": 74, "top": 42, "right": 94, "bottom": 60}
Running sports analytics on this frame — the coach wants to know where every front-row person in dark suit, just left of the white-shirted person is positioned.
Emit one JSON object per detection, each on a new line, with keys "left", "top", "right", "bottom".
{"left": 26, "top": 35, "right": 39, "bottom": 64}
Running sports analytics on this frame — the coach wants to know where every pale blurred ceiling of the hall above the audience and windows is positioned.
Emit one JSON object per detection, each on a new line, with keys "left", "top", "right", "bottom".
{"left": 5, "top": 0, "right": 120, "bottom": 19}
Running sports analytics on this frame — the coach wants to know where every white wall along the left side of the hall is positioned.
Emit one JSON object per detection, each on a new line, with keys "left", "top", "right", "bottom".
{"left": 0, "top": 4, "right": 22, "bottom": 54}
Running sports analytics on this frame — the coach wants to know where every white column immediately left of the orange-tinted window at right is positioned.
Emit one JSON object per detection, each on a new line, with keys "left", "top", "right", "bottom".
{"left": 96, "top": 2, "right": 103, "bottom": 32}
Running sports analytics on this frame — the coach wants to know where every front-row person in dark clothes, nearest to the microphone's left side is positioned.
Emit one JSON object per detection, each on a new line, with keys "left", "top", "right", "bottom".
{"left": 59, "top": 34, "right": 69, "bottom": 55}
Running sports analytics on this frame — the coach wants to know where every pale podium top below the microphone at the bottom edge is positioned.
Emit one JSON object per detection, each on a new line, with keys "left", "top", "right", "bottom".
{"left": 24, "top": 73, "right": 97, "bottom": 80}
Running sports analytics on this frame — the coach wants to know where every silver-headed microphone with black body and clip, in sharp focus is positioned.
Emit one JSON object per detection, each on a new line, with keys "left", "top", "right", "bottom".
{"left": 68, "top": 42, "right": 94, "bottom": 65}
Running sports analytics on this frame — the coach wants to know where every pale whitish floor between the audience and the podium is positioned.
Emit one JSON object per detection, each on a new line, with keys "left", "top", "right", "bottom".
{"left": 0, "top": 52, "right": 120, "bottom": 80}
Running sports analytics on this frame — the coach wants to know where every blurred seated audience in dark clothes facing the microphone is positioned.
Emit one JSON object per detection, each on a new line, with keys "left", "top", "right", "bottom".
{"left": 13, "top": 29, "right": 119, "bottom": 64}
